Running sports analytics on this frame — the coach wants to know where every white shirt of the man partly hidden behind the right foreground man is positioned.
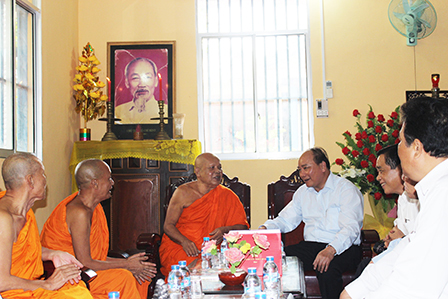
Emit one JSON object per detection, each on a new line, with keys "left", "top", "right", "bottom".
{"left": 394, "top": 191, "right": 420, "bottom": 236}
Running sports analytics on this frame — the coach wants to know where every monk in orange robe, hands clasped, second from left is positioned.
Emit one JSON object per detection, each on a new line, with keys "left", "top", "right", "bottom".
{"left": 41, "top": 159, "right": 156, "bottom": 299}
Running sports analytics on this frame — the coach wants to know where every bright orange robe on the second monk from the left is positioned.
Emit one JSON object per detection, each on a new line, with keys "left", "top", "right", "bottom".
{"left": 41, "top": 192, "right": 149, "bottom": 299}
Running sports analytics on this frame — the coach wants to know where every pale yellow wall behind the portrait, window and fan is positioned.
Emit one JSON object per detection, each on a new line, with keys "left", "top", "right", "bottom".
{"left": 28, "top": 0, "right": 448, "bottom": 227}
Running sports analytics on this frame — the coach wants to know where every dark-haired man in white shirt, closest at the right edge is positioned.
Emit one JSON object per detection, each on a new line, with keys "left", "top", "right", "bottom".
{"left": 340, "top": 98, "right": 448, "bottom": 299}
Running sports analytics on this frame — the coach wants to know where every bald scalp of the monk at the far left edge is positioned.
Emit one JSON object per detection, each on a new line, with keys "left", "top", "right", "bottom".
{"left": 2, "top": 153, "right": 43, "bottom": 190}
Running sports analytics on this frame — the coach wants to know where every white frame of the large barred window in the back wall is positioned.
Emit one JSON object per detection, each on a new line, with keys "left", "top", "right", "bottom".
{"left": 195, "top": 1, "right": 315, "bottom": 160}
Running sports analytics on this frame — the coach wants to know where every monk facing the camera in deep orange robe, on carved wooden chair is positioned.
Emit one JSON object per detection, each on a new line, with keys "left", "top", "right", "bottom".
{"left": 160, "top": 153, "right": 249, "bottom": 277}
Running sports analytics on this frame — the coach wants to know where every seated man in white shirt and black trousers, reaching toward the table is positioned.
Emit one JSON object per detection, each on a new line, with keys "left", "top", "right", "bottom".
{"left": 260, "top": 148, "right": 364, "bottom": 298}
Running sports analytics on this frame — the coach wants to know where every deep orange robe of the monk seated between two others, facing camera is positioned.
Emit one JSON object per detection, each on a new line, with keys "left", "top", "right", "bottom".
{"left": 159, "top": 185, "right": 249, "bottom": 277}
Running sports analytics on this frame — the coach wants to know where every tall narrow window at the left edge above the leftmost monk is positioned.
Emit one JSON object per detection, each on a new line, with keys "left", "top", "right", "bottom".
{"left": 0, "top": 0, "right": 41, "bottom": 157}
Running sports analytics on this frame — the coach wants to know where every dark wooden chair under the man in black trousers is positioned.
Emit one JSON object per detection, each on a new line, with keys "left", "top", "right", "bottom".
{"left": 268, "top": 170, "right": 380, "bottom": 299}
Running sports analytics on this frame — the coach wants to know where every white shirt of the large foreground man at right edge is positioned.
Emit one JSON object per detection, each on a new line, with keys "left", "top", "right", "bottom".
{"left": 346, "top": 160, "right": 448, "bottom": 299}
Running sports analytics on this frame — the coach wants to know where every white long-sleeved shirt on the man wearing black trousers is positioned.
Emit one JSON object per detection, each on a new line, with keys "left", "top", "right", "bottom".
{"left": 264, "top": 173, "right": 364, "bottom": 254}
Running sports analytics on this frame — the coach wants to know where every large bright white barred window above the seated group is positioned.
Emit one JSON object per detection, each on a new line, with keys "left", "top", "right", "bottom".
{"left": 197, "top": 0, "right": 312, "bottom": 159}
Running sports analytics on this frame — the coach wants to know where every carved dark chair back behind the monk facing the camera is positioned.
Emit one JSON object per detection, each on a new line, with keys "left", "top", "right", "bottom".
{"left": 164, "top": 173, "right": 250, "bottom": 225}
